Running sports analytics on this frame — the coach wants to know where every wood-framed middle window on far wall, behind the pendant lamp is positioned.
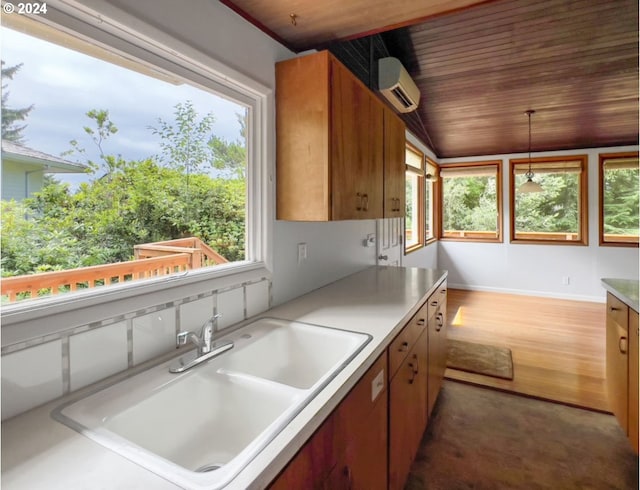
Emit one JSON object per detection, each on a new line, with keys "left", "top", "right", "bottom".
{"left": 509, "top": 155, "right": 588, "bottom": 245}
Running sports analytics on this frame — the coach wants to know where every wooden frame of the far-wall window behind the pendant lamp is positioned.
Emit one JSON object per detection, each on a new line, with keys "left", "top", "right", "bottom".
{"left": 509, "top": 155, "right": 589, "bottom": 246}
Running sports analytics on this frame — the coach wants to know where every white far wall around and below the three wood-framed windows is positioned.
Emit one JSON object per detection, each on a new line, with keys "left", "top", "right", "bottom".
{"left": 438, "top": 146, "right": 639, "bottom": 301}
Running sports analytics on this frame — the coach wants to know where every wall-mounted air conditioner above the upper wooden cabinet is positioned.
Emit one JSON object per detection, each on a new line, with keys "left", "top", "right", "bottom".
{"left": 378, "top": 57, "right": 420, "bottom": 112}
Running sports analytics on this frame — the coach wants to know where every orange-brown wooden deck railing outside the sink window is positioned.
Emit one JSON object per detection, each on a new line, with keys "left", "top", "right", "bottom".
{"left": 0, "top": 238, "right": 228, "bottom": 303}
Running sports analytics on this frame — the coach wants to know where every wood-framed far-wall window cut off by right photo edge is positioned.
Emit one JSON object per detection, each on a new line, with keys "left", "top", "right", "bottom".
{"left": 599, "top": 152, "right": 640, "bottom": 247}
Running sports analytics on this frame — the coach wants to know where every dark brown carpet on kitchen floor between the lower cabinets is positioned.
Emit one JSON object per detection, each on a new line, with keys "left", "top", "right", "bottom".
{"left": 405, "top": 380, "right": 638, "bottom": 490}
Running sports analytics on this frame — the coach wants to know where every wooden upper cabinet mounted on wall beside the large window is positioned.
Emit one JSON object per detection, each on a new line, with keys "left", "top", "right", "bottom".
{"left": 276, "top": 51, "right": 405, "bottom": 221}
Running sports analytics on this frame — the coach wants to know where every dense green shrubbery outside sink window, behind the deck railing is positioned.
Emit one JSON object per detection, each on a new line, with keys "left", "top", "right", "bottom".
{"left": 1, "top": 103, "right": 246, "bottom": 277}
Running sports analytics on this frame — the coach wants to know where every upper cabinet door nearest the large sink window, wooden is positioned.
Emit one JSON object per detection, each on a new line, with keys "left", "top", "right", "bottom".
{"left": 330, "top": 60, "right": 383, "bottom": 220}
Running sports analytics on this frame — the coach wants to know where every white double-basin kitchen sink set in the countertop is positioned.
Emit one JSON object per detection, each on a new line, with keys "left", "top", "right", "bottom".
{"left": 52, "top": 318, "right": 370, "bottom": 489}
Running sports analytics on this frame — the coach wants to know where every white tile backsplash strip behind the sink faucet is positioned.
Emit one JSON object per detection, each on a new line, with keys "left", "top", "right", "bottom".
{"left": 2, "top": 278, "right": 271, "bottom": 420}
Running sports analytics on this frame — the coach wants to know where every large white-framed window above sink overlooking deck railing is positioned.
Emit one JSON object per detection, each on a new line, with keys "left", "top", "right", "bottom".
{"left": 2, "top": 16, "right": 266, "bottom": 303}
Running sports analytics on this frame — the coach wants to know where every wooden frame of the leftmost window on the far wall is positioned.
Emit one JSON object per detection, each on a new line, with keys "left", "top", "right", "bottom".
{"left": 438, "top": 160, "right": 504, "bottom": 243}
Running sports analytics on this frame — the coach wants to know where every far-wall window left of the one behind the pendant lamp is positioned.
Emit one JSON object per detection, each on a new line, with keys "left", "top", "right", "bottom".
{"left": 440, "top": 161, "right": 502, "bottom": 242}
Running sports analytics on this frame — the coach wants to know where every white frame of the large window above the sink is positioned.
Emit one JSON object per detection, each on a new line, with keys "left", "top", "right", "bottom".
{"left": 3, "top": 6, "right": 274, "bottom": 323}
